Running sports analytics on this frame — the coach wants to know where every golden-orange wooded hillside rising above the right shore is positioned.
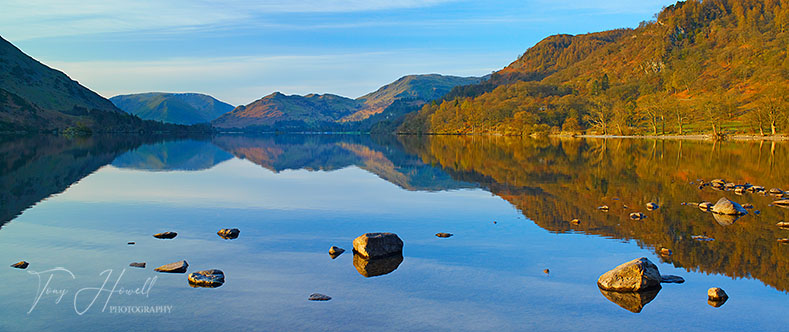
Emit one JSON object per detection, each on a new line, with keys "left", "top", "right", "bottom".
{"left": 399, "top": 0, "right": 789, "bottom": 137}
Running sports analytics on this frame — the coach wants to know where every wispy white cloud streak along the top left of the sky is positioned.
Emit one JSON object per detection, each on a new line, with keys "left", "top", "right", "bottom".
{"left": 0, "top": 0, "right": 457, "bottom": 40}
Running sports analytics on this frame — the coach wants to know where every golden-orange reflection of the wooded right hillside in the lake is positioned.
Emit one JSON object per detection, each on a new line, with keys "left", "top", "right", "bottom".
{"left": 401, "top": 136, "right": 789, "bottom": 291}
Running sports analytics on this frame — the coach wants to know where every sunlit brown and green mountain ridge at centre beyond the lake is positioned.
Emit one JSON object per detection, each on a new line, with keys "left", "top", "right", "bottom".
{"left": 211, "top": 74, "right": 481, "bottom": 131}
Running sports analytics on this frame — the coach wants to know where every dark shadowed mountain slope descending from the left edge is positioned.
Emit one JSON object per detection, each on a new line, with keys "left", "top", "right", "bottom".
{"left": 0, "top": 37, "right": 203, "bottom": 132}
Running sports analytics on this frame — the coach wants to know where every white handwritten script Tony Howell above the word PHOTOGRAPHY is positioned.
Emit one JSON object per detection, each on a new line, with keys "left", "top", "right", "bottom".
{"left": 27, "top": 267, "right": 160, "bottom": 316}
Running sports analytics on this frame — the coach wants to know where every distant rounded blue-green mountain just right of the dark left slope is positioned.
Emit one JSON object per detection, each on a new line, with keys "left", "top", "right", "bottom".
{"left": 110, "top": 92, "right": 233, "bottom": 125}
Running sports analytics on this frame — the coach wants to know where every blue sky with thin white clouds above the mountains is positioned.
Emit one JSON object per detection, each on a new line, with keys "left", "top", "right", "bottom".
{"left": 0, "top": 0, "right": 673, "bottom": 105}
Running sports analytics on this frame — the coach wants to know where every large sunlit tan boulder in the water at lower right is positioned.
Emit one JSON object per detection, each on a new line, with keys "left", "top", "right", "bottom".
{"left": 597, "top": 257, "right": 662, "bottom": 292}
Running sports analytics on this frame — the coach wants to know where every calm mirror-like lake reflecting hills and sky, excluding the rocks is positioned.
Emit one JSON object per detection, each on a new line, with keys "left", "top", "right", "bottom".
{"left": 0, "top": 135, "right": 789, "bottom": 331}
